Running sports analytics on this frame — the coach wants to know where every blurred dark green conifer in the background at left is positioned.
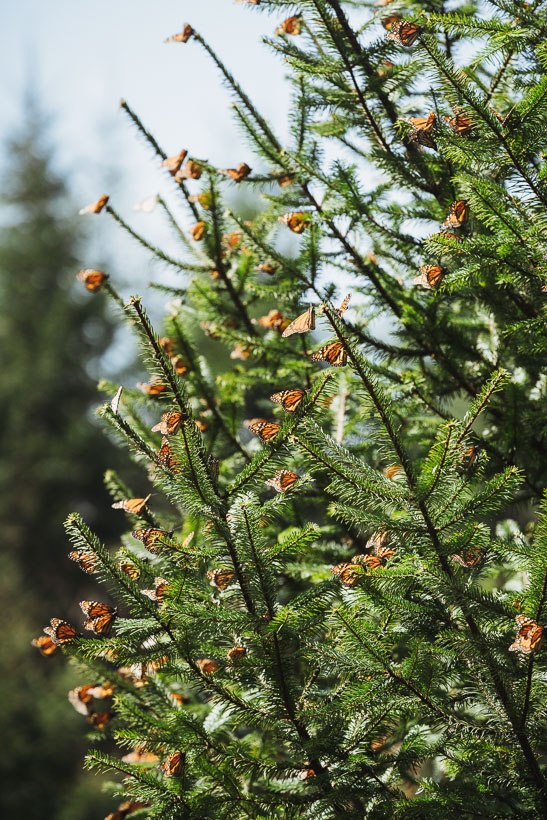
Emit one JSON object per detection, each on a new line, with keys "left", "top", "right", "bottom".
{"left": 0, "top": 106, "right": 128, "bottom": 820}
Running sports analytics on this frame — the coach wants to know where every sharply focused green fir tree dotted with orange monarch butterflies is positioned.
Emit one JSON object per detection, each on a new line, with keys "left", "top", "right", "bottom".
{"left": 41, "top": 0, "right": 547, "bottom": 818}
